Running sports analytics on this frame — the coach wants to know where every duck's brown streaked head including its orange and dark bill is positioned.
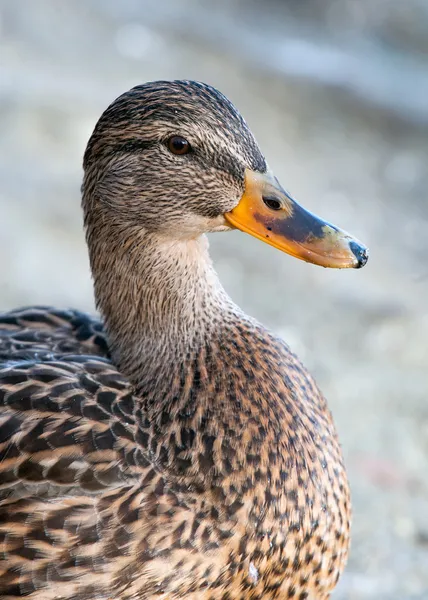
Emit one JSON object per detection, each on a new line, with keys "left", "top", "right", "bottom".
{"left": 83, "top": 81, "right": 368, "bottom": 268}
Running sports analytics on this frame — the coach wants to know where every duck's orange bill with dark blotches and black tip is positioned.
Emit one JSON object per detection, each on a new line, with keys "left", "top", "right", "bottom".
{"left": 225, "top": 169, "right": 368, "bottom": 269}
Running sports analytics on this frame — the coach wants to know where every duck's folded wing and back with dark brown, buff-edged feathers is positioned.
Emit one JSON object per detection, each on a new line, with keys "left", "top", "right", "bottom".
{"left": 0, "top": 308, "right": 149, "bottom": 600}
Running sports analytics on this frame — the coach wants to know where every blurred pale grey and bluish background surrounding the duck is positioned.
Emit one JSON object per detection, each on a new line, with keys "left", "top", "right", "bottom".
{"left": 0, "top": 0, "right": 428, "bottom": 600}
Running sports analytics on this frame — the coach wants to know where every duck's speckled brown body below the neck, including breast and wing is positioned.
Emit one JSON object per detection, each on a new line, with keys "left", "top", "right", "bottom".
{"left": 0, "top": 308, "right": 349, "bottom": 600}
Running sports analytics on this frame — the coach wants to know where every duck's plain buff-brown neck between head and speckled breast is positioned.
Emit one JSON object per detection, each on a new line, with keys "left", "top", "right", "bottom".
{"left": 87, "top": 224, "right": 234, "bottom": 393}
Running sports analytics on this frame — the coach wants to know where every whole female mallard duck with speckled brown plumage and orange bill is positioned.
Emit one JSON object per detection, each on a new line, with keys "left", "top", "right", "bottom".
{"left": 0, "top": 81, "right": 367, "bottom": 600}
